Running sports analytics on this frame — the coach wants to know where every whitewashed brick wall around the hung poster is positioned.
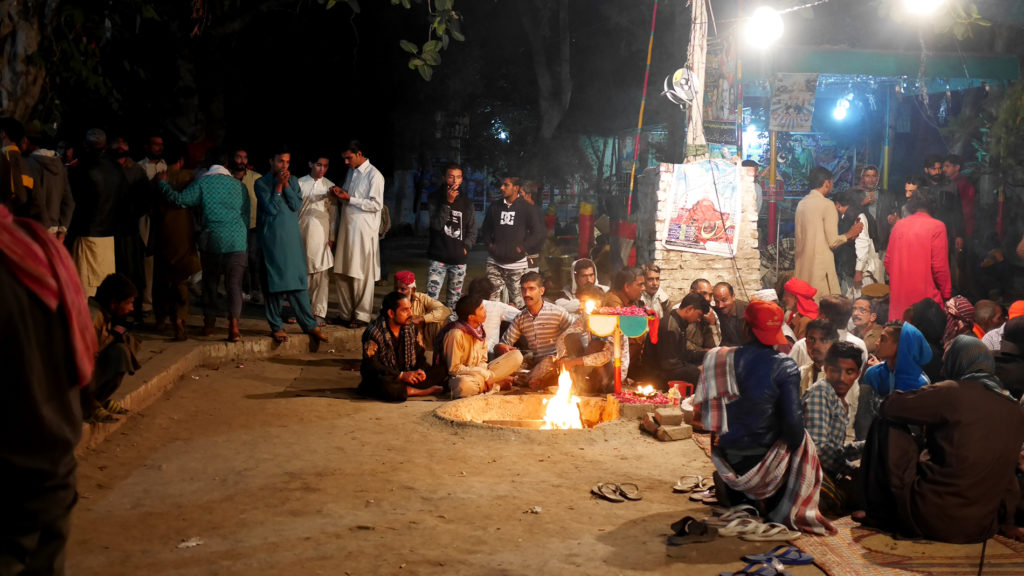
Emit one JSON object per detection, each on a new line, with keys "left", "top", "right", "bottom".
{"left": 654, "top": 164, "right": 761, "bottom": 304}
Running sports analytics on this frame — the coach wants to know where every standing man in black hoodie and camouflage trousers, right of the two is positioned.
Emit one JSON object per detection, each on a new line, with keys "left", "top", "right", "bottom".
{"left": 482, "top": 176, "right": 545, "bottom": 308}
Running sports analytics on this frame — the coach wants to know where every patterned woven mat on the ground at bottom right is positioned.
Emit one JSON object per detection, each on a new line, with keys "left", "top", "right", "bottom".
{"left": 798, "top": 512, "right": 1024, "bottom": 576}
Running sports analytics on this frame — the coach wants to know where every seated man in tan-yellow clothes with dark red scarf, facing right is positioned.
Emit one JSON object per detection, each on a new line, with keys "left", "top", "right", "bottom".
{"left": 435, "top": 294, "right": 522, "bottom": 400}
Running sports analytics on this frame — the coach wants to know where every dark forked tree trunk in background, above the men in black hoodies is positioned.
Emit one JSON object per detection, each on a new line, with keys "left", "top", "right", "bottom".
{"left": 519, "top": 0, "right": 572, "bottom": 140}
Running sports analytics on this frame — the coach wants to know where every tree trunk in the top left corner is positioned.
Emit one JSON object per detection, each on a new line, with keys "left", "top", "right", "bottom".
{"left": 0, "top": 0, "right": 48, "bottom": 122}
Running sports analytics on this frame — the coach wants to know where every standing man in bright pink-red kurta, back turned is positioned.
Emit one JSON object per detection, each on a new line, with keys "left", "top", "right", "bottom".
{"left": 885, "top": 190, "right": 952, "bottom": 322}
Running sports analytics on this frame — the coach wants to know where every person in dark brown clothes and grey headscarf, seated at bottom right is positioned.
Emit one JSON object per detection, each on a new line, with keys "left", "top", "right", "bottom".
{"left": 858, "top": 335, "right": 1024, "bottom": 543}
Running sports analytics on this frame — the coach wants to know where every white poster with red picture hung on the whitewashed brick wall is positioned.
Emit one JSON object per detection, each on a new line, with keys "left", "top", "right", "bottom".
{"left": 663, "top": 160, "right": 753, "bottom": 257}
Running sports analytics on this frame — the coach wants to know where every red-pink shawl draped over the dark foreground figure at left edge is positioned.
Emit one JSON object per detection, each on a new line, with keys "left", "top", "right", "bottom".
{"left": 0, "top": 206, "right": 98, "bottom": 387}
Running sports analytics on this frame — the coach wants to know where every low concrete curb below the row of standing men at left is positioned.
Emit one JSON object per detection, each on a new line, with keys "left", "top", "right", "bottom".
{"left": 75, "top": 327, "right": 362, "bottom": 455}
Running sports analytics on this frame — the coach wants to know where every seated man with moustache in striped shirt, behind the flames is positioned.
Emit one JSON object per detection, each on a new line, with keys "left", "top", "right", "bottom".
{"left": 495, "top": 272, "right": 572, "bottom": 389}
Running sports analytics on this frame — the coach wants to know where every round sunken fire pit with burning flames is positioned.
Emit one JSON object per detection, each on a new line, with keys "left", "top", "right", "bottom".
{"left": 434, "top": 372, "right": 618, "bottom": 429}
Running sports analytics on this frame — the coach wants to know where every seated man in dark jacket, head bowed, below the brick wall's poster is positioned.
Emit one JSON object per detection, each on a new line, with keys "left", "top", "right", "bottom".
{"left": 646, "top": 292, "right": 711, "bottom": 384}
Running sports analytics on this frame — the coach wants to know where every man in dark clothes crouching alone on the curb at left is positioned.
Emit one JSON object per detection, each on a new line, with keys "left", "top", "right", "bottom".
{"left": 82, "top": 274, "right": 140, "bottom": 422}
